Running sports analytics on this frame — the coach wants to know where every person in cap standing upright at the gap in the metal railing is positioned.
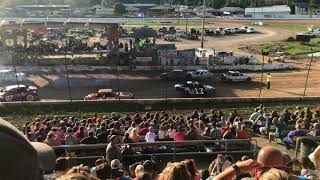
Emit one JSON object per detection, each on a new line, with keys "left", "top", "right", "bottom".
{"left": 106, "top": 135, "right": 122, "bottom": 164}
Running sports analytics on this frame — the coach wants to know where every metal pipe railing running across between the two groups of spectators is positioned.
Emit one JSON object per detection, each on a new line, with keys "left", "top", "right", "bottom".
{"left": 53, "top": 139, "right": 258, "bottom": 161}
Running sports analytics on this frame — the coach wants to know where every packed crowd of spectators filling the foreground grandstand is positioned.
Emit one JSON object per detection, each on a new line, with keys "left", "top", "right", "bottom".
{"left": 1, "top": 105, "right": 320, "bottom": 180}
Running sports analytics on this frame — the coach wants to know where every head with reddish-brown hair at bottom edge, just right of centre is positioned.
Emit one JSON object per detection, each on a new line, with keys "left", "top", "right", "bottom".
{"left": 159, "top": 163, "right": 192, "bottom": 180}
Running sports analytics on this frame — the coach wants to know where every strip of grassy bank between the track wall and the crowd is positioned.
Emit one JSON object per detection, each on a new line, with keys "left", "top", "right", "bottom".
{"left": 0, "top": 100, "right": 318, "bottom": 125}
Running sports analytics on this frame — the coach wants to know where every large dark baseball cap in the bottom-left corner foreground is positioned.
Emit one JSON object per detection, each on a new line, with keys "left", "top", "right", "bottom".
{"left": 0, "top": 118, "right": 56, "bottom": 180}
